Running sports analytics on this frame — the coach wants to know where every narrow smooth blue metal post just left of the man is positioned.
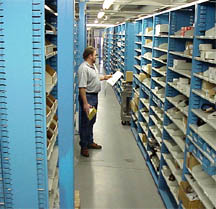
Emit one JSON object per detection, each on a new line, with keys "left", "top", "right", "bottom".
{"left": 58, "top": 0, "right": 74, "bottom": 209}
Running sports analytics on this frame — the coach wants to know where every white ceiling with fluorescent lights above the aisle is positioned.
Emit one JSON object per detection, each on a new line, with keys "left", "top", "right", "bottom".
{"left": 76, "top": 0, "right": 194, "bottom": 24}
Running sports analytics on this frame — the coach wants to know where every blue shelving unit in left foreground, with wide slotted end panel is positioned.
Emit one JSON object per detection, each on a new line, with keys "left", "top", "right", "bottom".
{"left": 0, "top": 0, "right": 76, "bottom": 208}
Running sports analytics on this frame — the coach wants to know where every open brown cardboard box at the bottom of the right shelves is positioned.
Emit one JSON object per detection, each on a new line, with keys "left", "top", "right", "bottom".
{"left": 178, "top": 181, "right": 204, "bottom": 209}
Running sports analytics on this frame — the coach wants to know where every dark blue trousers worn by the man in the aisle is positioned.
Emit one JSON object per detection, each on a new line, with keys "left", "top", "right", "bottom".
{"left": 79, "top": 93, "right": 98, "bottom": 148}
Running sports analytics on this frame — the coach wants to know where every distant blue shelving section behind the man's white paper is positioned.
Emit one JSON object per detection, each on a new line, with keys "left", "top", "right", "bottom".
{"left": 104, "top": 23, "right": 134, "bottom": 103}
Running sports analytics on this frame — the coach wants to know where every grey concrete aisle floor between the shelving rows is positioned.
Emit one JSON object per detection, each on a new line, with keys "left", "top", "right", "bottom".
{"left": 75, "top": 81, "right": 165, "bottom": 209}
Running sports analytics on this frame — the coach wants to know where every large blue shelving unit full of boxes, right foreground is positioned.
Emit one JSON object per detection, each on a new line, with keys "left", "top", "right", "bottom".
{"left": 104, "top": 0, "right": 216, "bottom": 209}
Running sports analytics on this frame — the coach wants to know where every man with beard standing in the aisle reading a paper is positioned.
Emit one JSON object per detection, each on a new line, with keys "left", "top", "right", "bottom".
{"left": 78, "top": 46, "right": 112, "bottom": 157}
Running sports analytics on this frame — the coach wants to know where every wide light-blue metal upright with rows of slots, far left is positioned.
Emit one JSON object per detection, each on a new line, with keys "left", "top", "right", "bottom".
{"left": 4, "top": 0, "right": 48, "bottom": 208}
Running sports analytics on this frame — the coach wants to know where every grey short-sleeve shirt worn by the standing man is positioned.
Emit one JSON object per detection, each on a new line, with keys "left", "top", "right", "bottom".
{"left": 78, "top": 61, "right": 101, "bottom": 93}
